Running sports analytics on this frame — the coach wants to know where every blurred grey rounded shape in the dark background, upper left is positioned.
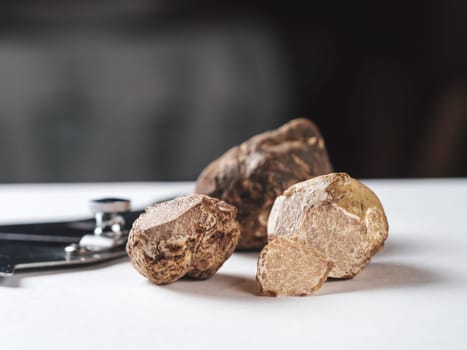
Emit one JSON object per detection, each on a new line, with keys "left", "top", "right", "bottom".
{"left": 0, "top": 23, "right": 293, "bottom": 182}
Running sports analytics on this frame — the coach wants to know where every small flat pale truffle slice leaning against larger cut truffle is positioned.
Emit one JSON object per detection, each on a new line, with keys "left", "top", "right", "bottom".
{"left": 256, "top": 236, "right": 334, "bottom": 296}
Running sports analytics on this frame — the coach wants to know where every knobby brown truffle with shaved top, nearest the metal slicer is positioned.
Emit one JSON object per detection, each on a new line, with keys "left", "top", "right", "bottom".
{"left": 126, "top": 194, "right": 240, "bottom": 284}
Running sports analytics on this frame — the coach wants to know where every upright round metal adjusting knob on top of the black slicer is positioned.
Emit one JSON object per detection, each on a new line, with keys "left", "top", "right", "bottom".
{"left": 89, "top": 198, "right": 131, "bottom": 238}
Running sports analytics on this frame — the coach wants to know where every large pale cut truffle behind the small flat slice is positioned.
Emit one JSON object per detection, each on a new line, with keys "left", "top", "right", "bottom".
{"left": 268, "top": 173, "right": 388, "bottom": 278}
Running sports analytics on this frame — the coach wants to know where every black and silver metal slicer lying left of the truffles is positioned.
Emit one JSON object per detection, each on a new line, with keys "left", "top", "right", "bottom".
{"left": 0, "top": 198, "right": 151, "bottom": 277}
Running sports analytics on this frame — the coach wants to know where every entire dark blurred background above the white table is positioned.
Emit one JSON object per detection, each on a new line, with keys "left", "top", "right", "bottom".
{"left": 0, "top": 0, "right": 467, "bottom": 182}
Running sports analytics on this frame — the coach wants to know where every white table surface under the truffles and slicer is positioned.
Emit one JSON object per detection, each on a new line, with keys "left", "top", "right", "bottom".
{"left": 0, "top": 179, "right": 467, "bottom": 350}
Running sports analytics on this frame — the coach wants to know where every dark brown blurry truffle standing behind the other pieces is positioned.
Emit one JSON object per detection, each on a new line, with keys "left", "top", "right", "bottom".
{"left": 195, "top": 119, "right": 332, "bottom": 250}
